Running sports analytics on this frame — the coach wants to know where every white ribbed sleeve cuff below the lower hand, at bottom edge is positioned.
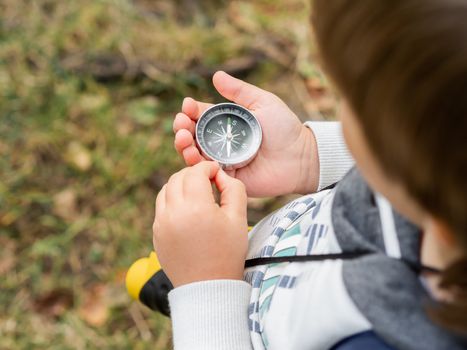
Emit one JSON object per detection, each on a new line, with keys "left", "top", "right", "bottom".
{"left": 169, "top": 280, "right": 252, "bottom": 350}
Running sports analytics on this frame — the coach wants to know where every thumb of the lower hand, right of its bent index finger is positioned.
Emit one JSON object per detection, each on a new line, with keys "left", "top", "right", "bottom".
{"left": 214, "top": 170, "right": 247, "bottom": 215}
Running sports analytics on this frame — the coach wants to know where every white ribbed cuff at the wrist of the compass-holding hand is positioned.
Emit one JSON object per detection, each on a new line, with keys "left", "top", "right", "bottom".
{"left": 305, "top": 121, "right": 354, "bottom": 191}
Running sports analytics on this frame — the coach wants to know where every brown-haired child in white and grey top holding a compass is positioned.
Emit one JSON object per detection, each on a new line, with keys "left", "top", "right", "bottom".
{"left": 153, "top": 0, "right": 467, "bottom": 350}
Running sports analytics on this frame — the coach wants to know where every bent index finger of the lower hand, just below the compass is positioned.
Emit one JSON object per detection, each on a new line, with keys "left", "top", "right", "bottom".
{"left": 183, "top": 162, "right": 219, "bottom": 203}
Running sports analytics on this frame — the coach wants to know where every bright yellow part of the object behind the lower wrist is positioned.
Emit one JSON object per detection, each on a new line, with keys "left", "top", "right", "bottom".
{"left": 125, "top": 252, "right": 161, "bottom": 300}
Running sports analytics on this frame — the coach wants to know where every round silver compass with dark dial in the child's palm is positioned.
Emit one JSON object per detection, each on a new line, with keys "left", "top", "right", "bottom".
{"left": 195, "top": 103, "right": 262, "bottom": 170}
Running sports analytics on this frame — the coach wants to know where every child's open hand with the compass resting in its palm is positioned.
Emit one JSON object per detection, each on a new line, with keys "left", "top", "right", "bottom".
{"left": 173, "top": 72, "right": 319, "bottom": 197}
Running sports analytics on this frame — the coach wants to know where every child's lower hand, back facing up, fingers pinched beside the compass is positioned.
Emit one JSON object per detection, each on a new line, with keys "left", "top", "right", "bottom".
{"left": 153, "top": 162, "right": 248, "bottom": 287}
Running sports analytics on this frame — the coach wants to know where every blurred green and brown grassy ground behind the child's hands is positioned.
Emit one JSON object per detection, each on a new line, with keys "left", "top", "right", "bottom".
{"left": 0, "top": 0, "right": 334, "bottom": 349}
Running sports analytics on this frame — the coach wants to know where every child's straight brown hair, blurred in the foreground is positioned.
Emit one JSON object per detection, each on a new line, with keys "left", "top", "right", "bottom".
{"left": 312, "top": 0, "right": 467, "bottom": 333}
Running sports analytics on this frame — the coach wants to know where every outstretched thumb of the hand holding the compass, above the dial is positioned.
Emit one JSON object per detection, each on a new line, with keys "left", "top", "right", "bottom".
{"left": 212, "top": 71, "right": 272, "bottom": 110}
